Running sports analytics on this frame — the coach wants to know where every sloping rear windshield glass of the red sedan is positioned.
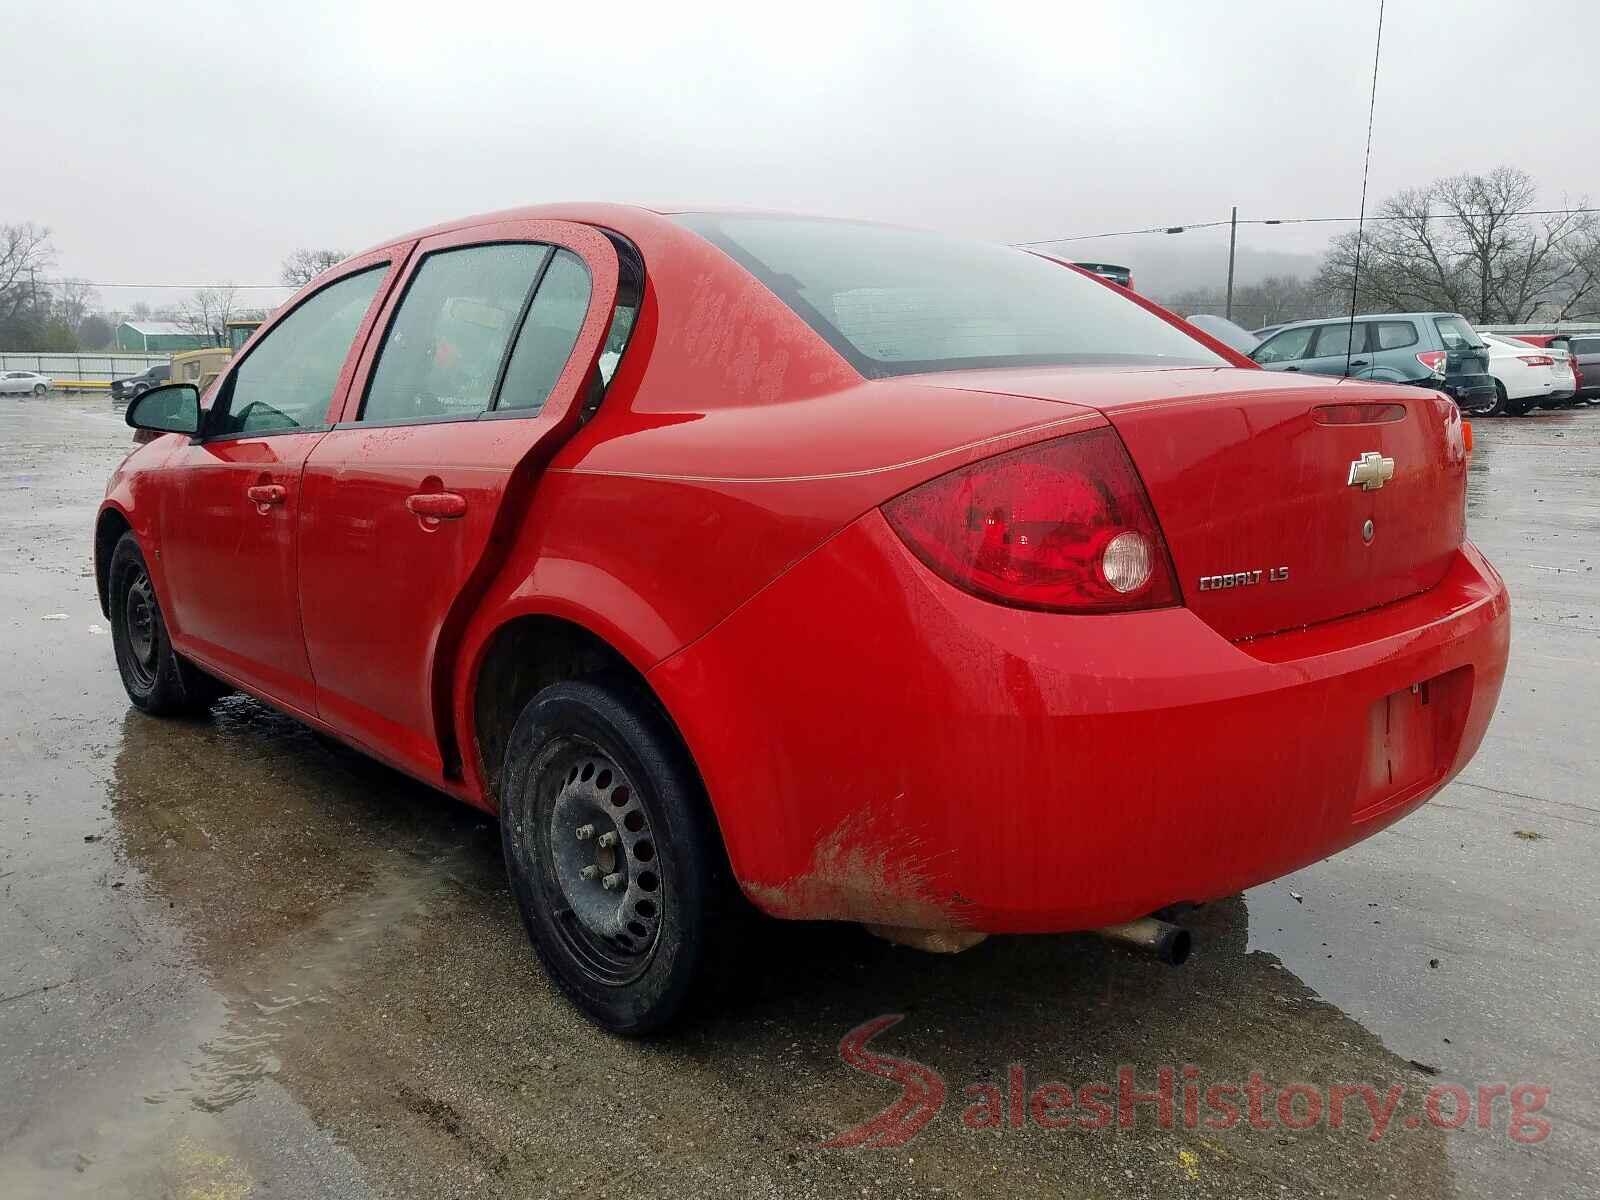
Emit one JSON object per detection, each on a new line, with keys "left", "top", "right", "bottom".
{"left": 675, "top": 213, "right": 1227, "bottom": 379}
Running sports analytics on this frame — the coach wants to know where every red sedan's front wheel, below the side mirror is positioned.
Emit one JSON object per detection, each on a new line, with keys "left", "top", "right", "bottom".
{"left": 107, "top": 531, "right": 227, "bottom": 717}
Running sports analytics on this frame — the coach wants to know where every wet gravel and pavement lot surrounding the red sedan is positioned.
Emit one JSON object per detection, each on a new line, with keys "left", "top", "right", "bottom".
{"left": 0, "top": 397, "right": 1600, "bottom": 1198}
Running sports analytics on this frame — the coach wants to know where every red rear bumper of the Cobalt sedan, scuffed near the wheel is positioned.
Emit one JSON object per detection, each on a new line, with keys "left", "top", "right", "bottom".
{"left": 651, "top": 512, "right": 1510, "bottom": 931}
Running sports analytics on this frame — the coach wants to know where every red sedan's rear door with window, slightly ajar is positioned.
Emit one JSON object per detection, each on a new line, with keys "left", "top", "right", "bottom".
{"left": 299, "top": 221, "right": 618, "bottom": 778}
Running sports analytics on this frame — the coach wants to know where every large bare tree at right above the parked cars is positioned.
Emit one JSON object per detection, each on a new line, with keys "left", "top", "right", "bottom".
{"left": 1317, "top": 166, "right": 1600, "bottom": 323}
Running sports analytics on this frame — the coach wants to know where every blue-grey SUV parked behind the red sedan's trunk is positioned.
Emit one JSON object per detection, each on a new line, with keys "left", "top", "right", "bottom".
{"left": 1250, "top": 312, "right": 1496, "bottom": 413}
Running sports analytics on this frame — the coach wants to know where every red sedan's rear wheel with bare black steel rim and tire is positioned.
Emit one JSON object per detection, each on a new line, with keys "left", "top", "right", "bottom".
{"left": 499, "top": 678, "right": 731, "bottom": 1035}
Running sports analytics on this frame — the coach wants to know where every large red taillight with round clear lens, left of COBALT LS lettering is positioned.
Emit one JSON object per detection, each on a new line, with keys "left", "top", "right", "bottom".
{"left": 883, "top": 426, "right": 1182, "bottom": 613}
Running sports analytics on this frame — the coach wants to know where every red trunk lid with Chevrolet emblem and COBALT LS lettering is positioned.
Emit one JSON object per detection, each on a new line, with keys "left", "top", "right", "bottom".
{"left": 908, "top": 368, "right": 1467, "bottom": 640}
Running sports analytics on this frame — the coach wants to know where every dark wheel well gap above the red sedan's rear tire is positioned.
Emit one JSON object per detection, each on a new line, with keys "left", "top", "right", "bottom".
{"left": 472, "top": 616, "right": 649, "bottom": 803}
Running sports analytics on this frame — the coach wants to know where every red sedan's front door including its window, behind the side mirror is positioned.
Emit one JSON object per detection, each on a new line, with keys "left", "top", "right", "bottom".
{"left": 160, "top": 249, "right": 403, "bottom": 712}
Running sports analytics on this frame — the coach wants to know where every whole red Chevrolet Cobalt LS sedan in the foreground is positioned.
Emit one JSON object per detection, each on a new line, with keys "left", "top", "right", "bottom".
{"left": 94, "top": 205, "right": 1510, "bottom": 1032}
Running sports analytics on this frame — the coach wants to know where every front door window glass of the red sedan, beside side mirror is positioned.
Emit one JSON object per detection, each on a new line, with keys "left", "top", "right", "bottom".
{"left": 209, "top": 264, "right": 389, "bottom": 435}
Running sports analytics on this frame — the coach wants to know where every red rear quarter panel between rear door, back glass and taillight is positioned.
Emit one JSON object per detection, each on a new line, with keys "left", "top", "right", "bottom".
{"left": 451, "top": 218, "right": 1104, "bottom": 809}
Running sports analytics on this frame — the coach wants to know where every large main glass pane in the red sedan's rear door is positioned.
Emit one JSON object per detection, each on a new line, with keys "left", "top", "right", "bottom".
{"left": 360, "top": 242, "right": 547, "bottom": 421}
